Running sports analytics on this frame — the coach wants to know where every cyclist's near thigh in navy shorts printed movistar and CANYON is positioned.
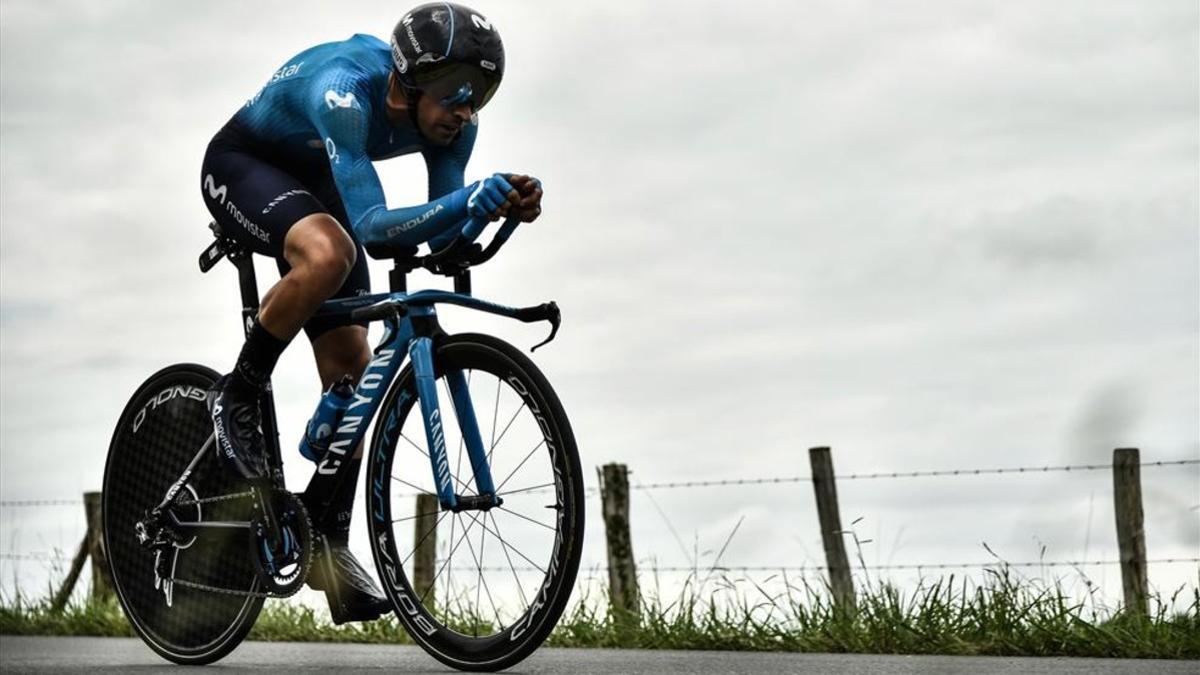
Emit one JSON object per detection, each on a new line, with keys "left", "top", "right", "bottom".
{"left": 200, "top": 135, "right": 325, "bottom": 258}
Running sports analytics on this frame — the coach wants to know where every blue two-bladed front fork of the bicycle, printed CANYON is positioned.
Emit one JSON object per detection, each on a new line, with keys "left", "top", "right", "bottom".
{"left": 408, "top": 338, "right": 503, "bottom": 512}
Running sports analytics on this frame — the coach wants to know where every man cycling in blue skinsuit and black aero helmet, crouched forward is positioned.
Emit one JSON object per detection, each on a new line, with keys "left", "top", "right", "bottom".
{"left": 200, "top": 2, "right": 542, "bottom": 623}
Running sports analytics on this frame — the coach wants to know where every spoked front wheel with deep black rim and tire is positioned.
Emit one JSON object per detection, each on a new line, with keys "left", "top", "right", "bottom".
{"left": 366, "top": 334, "right": 584, "bottom": 670}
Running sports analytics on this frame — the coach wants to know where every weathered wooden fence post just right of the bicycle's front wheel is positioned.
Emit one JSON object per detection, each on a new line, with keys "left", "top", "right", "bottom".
{"left": 599, "top": 464, "right": 641, "bottom": 615}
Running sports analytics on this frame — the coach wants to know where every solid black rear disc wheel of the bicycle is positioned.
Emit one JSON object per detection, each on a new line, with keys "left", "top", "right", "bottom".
{"left": 103, "top": 364, "right": 263, "bottom": 664}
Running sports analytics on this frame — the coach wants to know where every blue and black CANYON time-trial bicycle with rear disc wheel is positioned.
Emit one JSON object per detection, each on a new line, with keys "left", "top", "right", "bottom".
{"left": 103, "top": 219, "right": 584, "bottom": 670}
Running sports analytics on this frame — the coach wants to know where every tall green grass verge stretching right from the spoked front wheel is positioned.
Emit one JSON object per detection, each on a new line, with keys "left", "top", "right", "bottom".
{"left": 548, "top": 567, "right": 1200, "bottom": 658}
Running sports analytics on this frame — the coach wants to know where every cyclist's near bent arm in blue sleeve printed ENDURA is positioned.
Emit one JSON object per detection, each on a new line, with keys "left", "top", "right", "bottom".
{"left": 313, "top": 79, "right": 470, "bottom": 246}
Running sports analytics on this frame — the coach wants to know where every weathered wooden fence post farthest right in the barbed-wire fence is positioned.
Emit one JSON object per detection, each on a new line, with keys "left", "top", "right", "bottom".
{"left": 1112, "top": 448, "right": 1148, "bottom": 616}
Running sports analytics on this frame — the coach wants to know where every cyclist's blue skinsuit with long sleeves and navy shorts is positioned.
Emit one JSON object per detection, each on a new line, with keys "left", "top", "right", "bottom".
{"left": 200, "top": 35, "right": 478, "bottom": 338}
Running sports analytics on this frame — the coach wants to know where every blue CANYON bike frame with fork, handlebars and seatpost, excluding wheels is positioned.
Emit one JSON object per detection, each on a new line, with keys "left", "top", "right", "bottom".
{"left": 199, "top": 217, "right": 560, "bottom": 530}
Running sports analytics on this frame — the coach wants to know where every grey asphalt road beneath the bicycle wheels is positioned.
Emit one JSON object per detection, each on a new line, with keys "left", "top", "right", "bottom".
{"left": 0, "top": 635, "right": 1200, "bottom": 675}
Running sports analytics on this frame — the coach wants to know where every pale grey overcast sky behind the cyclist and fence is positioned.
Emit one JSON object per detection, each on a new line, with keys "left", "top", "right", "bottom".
{"left": 0, "top": 0, "right": 1200, "bottom": 607}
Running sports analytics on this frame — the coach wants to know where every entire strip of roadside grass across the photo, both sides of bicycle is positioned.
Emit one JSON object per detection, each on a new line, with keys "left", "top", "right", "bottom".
{"left": 0, "top": 563, "right": 1200, "bottom": 658}
